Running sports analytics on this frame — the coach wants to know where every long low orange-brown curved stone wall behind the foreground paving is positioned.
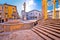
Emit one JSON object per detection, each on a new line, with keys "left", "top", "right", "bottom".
{"left": 0, "top": 22, "right": 36, "bottom": 32}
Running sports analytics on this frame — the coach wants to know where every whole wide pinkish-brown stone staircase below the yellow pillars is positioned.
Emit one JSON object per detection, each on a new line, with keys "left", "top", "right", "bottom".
{"left": 32, "top": 20, "right": 60, "bottom": 40}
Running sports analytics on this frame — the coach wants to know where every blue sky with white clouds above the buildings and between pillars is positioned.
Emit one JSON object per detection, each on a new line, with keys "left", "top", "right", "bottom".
{"left": 0, "top": 0, "right": 58, "bottom": 15}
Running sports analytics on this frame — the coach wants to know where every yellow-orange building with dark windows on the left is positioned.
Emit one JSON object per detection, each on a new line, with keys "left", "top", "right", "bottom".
{"left": 0, "top": 3, "right": 19, "bottom": 22}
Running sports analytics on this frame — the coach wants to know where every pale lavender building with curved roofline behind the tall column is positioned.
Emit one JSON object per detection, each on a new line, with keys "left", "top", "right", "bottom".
{"left": 21, "top": 10, "right": 42, "bottom": 20}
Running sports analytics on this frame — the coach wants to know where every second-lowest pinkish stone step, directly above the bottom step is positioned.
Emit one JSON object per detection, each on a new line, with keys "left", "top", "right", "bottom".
{"left": 31, "top": 28, "right": 59, "bottom": 40}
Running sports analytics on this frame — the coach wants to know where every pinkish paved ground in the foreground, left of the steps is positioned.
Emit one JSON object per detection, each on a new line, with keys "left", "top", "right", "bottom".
{"left": 3, "top": 30, "right": 42, "bottom": 40}
